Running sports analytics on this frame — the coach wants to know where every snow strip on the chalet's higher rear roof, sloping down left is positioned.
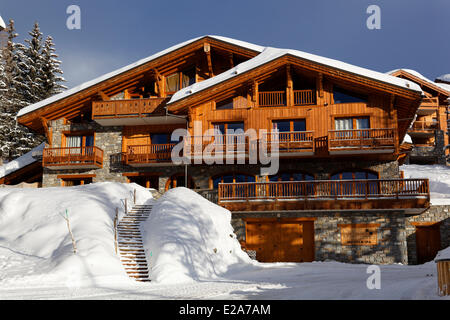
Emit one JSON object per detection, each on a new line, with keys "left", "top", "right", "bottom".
{"left": 17, "top": 35, "right": 264, "bottom": 117}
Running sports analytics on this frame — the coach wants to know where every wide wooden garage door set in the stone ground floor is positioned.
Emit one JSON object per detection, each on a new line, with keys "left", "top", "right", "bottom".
{"left": 246, "top": 219, "right": 314, "bottom": 262}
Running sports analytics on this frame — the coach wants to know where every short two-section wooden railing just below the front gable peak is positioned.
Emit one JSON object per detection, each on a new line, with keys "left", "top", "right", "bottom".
{"left": 258, "top": 90, "right": 316, "bottom": 107}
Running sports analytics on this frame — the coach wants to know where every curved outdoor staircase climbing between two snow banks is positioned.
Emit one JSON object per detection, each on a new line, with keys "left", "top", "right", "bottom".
{"left": 117, "top": 205, "right": 152, "bottom": 282}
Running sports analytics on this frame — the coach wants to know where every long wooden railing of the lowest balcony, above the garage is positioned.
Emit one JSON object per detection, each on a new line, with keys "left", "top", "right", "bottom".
{"left": 219, "top": 179, "right": 430, "bottom": 203}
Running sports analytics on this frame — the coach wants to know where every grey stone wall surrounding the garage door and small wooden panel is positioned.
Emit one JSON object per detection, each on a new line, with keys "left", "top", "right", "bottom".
{"left": 232, "top": 212, "right": 408, "bottom": 264}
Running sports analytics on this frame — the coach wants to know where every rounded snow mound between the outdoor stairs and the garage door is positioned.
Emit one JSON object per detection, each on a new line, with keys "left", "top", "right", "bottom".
{"left": 142, "top": 188, "right": 253, "bottom": 283}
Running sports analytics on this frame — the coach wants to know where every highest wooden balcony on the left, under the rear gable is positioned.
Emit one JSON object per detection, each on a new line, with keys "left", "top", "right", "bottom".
{"left": 92, "top": 98, "right": 185, "bottom": 126}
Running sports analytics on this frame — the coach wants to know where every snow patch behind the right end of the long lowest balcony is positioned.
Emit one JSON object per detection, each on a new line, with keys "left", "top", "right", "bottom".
{"left": 400, "top": 164, "right": 450, "bottom": 205}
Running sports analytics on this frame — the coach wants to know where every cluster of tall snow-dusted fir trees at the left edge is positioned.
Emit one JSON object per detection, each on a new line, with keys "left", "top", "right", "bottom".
{"left": 0, "top": 20, "right": 65, "bottom": 160}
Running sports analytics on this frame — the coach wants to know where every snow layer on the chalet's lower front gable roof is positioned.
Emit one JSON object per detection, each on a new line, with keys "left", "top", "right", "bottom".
{"left": 168, "top": 47, "right": 422, "bottom": 104}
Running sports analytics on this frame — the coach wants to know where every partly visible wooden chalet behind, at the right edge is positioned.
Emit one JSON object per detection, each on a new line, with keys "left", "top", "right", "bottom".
{"left": 389, "top": 69, "right": 450, "bottom": 164}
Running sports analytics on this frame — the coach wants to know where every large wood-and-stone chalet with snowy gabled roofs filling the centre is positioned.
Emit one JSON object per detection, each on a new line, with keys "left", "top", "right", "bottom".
{"left": 13, "top": 36, "right": 448, "bottom": 263}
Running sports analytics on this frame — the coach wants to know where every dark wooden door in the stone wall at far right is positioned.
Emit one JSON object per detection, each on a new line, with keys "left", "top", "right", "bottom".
{"left": 416, "top": 223, "right": 441, "bottom": 264}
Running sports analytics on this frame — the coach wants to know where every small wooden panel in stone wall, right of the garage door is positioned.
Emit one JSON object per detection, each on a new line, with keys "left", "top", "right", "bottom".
{"left": 338, "top": 224, "right": 380, "bottom": 246}
